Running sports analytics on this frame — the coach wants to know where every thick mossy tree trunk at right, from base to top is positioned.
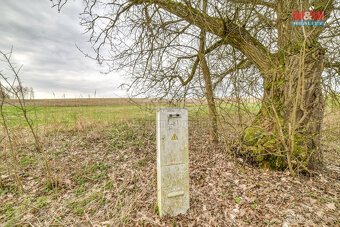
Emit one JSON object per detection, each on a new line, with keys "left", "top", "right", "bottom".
{"left": 243, "top": 1, "right": 325, "bottom": 173}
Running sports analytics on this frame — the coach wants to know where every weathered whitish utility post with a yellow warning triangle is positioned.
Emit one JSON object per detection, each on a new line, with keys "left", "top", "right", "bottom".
{"left": 157, "top": 109, "right": 189, "bottom": 217}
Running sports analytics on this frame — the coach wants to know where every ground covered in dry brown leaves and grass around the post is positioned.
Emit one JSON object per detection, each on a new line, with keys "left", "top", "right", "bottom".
{"left": 0, "top": 117, "right": 340, "bottom": 226}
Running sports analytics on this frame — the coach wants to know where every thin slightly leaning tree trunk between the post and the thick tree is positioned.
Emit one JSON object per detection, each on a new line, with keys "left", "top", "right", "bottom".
{"left": 198, "top": 0, "right": 218, "bottom": 144}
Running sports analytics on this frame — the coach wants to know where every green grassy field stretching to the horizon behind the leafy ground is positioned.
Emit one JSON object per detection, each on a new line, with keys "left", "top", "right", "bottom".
{"left": 0, "top": 99, "right": 259, "bottom": 127}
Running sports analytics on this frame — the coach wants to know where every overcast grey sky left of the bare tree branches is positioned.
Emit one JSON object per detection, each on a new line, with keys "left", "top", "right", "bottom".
{"left": 0, "top": 0, "right": 126, "bottom": 98}
